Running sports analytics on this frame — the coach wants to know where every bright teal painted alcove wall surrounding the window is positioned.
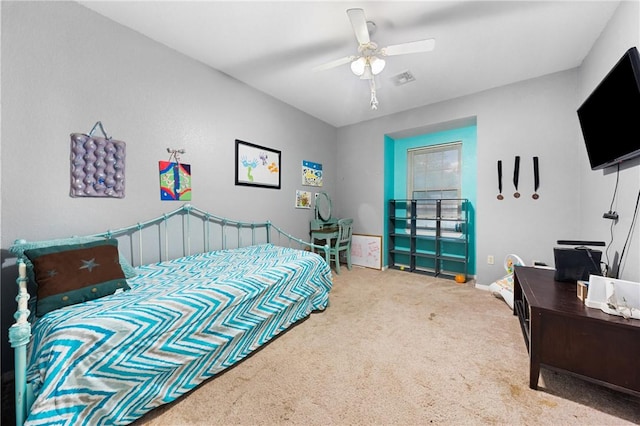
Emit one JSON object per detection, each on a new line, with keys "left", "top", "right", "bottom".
{"left": 384, "top": 125, "right": 478, "bottom": 275}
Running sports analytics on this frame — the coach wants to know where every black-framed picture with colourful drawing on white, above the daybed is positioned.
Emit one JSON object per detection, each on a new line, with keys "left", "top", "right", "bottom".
{"left": 236, "top": 139, "right": 281, "bottom": 189}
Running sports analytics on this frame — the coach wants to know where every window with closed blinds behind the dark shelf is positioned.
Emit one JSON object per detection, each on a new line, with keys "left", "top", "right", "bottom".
{"left": 407, "top": 142, "right": 462, "bottom": 228}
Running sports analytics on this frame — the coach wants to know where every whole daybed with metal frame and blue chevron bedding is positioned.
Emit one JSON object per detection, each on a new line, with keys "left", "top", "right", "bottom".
{"left": 9, "top": 205, "right": 332, "bottom": 425}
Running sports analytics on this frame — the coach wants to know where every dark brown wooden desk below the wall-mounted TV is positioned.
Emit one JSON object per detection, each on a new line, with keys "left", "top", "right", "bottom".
{"left": 513, "top": 266, "right": 640, "bottom": 396}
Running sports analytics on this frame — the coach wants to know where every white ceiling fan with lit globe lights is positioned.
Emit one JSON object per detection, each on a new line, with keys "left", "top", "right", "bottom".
{"left": 313, "top": 9, "right": 436, "bottom": 110}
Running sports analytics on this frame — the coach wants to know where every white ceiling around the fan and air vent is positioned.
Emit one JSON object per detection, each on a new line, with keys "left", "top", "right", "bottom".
{"left": 80, "top": 0, "right": 619, "bottom": 127}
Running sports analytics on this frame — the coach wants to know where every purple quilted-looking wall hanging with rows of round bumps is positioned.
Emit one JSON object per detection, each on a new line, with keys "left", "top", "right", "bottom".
{"left": 70, "top": 122, "right": 126, "bottom": 198}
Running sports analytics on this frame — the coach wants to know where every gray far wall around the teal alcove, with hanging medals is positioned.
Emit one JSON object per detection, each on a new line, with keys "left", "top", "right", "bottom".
{"left": 337, "top": 70, "right": 581, "bottom": 284}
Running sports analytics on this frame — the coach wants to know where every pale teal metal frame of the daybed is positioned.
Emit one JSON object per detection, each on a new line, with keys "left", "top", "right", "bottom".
{"left": 9, "top": 204, "right": 330, "bottom": 426}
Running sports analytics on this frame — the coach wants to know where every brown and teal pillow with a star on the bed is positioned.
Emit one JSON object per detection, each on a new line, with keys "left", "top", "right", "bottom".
{"left": 24, "top": 239, "right": 129, "bottom": 317}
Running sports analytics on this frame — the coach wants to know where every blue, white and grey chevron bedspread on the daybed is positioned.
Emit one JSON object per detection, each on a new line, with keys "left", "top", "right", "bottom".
{"left": 22, "top": 244, "right": 332, "bottom": 425}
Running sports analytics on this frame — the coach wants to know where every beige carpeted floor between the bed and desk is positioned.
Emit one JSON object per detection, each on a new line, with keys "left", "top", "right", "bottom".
{"left": 135, "top": 267, "right": 640, "bottom": 426}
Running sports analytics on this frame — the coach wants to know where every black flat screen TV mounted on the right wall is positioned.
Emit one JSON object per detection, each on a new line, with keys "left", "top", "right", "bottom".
{"left": 578, "top": 47, "right": 640, "bottom": 170}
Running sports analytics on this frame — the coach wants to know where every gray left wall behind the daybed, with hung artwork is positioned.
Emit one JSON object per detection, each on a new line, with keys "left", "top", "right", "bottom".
{"left": 0, "top": 2, "right": 336, "bottom": 371}
